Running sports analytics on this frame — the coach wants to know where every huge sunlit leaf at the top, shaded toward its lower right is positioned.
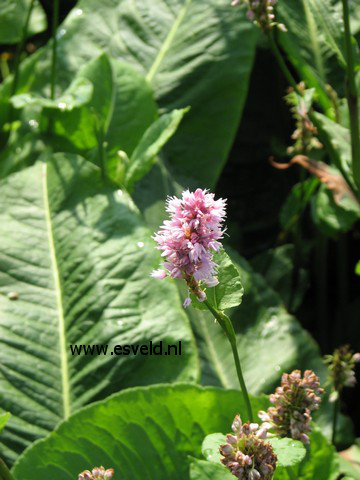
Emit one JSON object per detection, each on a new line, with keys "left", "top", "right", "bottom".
{"left": 9, "top": 0, "right": 257, "bottom": 185}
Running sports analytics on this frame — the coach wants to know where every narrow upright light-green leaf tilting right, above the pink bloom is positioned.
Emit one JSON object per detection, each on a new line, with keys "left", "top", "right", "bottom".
{"left": 125, "top": 108, "right": 189, "bottom": 191}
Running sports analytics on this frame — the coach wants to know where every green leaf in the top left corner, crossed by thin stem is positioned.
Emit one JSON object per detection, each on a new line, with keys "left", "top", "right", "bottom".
{"left": 0, "top": 0, "right": 46, "bottom": 44}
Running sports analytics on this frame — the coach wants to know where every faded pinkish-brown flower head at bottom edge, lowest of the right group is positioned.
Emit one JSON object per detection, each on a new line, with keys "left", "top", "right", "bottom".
{"left": 220, "top": 415, "right": 277, "bottom": 480}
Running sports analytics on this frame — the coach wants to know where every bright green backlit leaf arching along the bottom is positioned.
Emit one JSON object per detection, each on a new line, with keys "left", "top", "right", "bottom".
{"left": 13, "top": 385, "right": 266, "bottom": 480}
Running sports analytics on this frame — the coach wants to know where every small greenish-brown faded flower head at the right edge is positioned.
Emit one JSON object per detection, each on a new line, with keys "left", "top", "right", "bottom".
{"left": 325, "top": 345, "right": 360, "bottom": 400}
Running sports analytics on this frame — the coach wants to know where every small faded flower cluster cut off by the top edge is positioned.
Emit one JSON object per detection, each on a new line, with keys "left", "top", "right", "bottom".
{"left": 231, "top": 0, "right": 287, "bottom": 33}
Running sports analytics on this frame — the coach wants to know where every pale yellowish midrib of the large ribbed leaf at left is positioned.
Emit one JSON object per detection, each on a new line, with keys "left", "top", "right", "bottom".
{"left": 42, "top": 162, "right": 70, "bottom": 419}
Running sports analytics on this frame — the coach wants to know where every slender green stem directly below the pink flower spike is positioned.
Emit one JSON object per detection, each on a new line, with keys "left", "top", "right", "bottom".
{"left": 204, "top": 300, "right": 254, "bottom": 422}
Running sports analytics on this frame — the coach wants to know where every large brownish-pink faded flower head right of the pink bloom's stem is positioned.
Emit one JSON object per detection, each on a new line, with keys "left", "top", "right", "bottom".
{"left": 259, "top": 370, "right": 324, "bottom": 444}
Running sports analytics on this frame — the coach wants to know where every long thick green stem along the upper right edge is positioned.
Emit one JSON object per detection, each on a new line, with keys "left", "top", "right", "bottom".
{"left": 342, "top": 0, "right": 360, "bottom": 189}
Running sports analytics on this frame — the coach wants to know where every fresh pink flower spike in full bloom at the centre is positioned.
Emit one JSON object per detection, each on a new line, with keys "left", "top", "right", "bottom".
{"left": 151, "top": 188, "right": 226, "bottom": 307}
